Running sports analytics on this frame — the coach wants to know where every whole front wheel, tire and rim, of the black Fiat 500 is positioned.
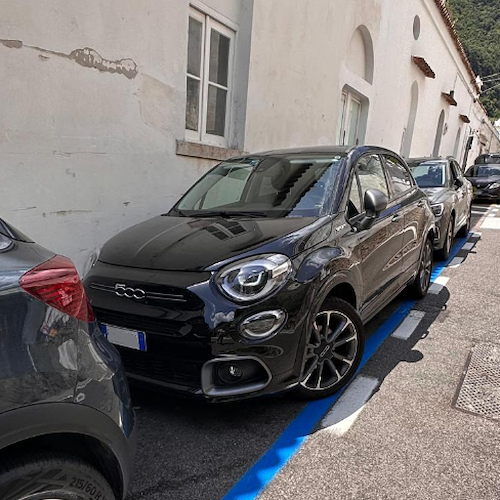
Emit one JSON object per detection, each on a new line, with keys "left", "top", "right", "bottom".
{"left": 295, "top": 297, "right": 365, "bottom": 400}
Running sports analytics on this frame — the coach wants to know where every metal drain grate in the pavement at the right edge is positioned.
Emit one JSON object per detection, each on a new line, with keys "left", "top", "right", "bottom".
{"left": 454, "top": 344, "right": 500, "bottom": 420}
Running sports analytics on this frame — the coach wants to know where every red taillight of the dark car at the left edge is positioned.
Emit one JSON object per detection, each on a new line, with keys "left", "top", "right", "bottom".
{"left": 19, "top": 255, "right": 95, "bottom": 323}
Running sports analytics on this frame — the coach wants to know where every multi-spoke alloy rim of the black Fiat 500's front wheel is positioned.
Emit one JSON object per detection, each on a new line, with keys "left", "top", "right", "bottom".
{"left": 301, "top": 311, "right": 359, "bottom": 391}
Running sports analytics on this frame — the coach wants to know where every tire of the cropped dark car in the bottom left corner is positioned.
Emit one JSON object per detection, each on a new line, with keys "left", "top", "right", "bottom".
{"left": 0, "top": 453, "right": 116, "bottom": 500}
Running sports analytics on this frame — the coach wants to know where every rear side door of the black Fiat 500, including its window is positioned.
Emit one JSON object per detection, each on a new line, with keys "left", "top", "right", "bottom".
{"left": 383, "top": 154, "right": 427, "bottom": 285}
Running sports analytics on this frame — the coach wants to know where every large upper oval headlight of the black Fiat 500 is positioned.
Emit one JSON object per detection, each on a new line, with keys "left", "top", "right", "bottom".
{"left": 216, "top": 254, "right": 292, "bottom": 302}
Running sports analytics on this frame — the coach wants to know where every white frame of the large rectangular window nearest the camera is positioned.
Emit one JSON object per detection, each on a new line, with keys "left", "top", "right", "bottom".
{"left": 186, "top": 6, "right": 236, "bottom": 148}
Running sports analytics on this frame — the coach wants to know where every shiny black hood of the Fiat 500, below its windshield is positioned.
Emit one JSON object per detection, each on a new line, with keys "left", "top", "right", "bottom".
{"left": 99, "top": 216, "right": 331, "bottom": 271}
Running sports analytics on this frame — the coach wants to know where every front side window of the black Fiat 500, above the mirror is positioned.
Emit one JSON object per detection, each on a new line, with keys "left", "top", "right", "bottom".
{"left": 347, "top": 155, "right": 389, "bottom": 218}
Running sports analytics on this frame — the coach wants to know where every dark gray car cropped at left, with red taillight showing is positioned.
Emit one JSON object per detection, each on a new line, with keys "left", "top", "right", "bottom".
{"left": 0, "top": 219, "right": 135, "bottom": 500}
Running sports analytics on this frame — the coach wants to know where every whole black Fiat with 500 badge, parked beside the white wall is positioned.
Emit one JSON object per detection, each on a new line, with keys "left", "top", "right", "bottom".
{"left": 85, "top": 146, "right": 434, "bottom": 400}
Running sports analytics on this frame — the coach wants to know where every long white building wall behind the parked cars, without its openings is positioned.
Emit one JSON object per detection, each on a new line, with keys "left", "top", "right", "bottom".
{"left": 0, "top": 0, "right": 500, "bottom": 269}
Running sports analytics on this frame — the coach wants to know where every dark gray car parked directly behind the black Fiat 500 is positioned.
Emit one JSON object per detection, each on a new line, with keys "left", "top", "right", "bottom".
{"left": 408, "top": 158, "right": 472, "bottom": 259}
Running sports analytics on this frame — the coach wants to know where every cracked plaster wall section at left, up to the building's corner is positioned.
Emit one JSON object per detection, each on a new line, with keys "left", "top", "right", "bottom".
{"left": 0, "top": 0, "right": 252, "bottom": 270}
